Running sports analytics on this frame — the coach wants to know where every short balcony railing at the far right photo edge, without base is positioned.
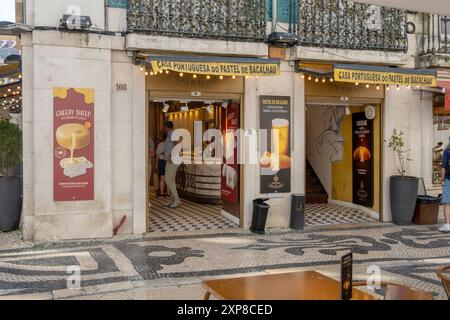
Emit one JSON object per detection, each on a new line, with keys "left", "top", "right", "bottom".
{"left": 422, "top": 14, "right": 450, "bottom": 54}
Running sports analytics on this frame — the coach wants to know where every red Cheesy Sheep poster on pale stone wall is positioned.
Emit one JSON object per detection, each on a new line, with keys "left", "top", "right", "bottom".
{"left": 53, "top": 88, "right": 94, "bottom": 201}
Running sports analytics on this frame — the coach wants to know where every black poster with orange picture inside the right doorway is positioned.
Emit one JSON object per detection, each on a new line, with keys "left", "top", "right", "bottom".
{"left": 353, "top": 112, "right": 374, "bottom": 208}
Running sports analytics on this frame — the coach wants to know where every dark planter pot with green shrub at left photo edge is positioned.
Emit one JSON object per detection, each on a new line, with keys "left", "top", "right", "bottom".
{"left": 0, "top": 177, "right": 22, "bottom": 231}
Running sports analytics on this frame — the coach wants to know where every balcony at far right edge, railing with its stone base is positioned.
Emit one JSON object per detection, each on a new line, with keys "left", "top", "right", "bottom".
{"left": 420, "top": 14, "right": 450, "bottom": 68}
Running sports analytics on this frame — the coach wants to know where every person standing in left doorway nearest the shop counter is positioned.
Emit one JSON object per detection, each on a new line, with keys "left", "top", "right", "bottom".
{"left": 164, "top": 121, "right": 181, "bottom": 209}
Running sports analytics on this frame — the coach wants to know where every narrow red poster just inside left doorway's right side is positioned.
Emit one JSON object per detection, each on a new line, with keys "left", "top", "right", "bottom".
{"left": 222, "top": 103, "right": 239, "bottom": 204}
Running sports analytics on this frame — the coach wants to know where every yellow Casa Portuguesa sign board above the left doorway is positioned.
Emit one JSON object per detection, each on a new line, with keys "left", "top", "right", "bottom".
{"left": 151, "top": 60, "right": 280, "bottom": 76}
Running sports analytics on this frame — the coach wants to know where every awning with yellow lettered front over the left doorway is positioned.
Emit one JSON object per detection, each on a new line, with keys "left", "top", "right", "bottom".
{"left": 146, "top": 56, "right": 280, "bottom": 76}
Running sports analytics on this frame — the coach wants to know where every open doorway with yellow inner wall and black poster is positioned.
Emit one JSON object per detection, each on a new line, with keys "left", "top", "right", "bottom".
{"left": 306, "top": 101, "right": 382, "bottom": 226}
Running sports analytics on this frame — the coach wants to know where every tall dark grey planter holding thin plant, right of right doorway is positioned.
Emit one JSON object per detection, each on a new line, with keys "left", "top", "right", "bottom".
{"left": 390, "top": 176, "right": 419, "bottom": 225}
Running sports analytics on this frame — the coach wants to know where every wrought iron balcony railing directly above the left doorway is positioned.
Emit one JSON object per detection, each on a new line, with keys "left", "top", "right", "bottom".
{"left": 128, "top": 0, "right": 266, "bottom": 41}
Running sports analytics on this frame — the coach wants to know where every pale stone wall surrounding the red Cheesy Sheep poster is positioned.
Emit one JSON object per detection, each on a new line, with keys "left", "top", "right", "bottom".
{"left": 23, "top": 31, "right": 145, "bottom": 241}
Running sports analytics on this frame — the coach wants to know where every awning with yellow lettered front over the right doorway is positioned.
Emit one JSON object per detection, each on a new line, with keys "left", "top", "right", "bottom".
{"left": 334, "top": 64, "right": 437, "bottom": 87}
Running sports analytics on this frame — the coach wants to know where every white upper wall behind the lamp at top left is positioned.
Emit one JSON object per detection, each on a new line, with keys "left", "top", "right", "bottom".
{"left": 25, "top": 0, "right": 105, "bottom": 30}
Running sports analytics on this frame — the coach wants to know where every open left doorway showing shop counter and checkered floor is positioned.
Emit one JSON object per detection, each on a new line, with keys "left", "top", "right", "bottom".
{"left": 147, "top": 97, "right": 241, "bottom": 232}
